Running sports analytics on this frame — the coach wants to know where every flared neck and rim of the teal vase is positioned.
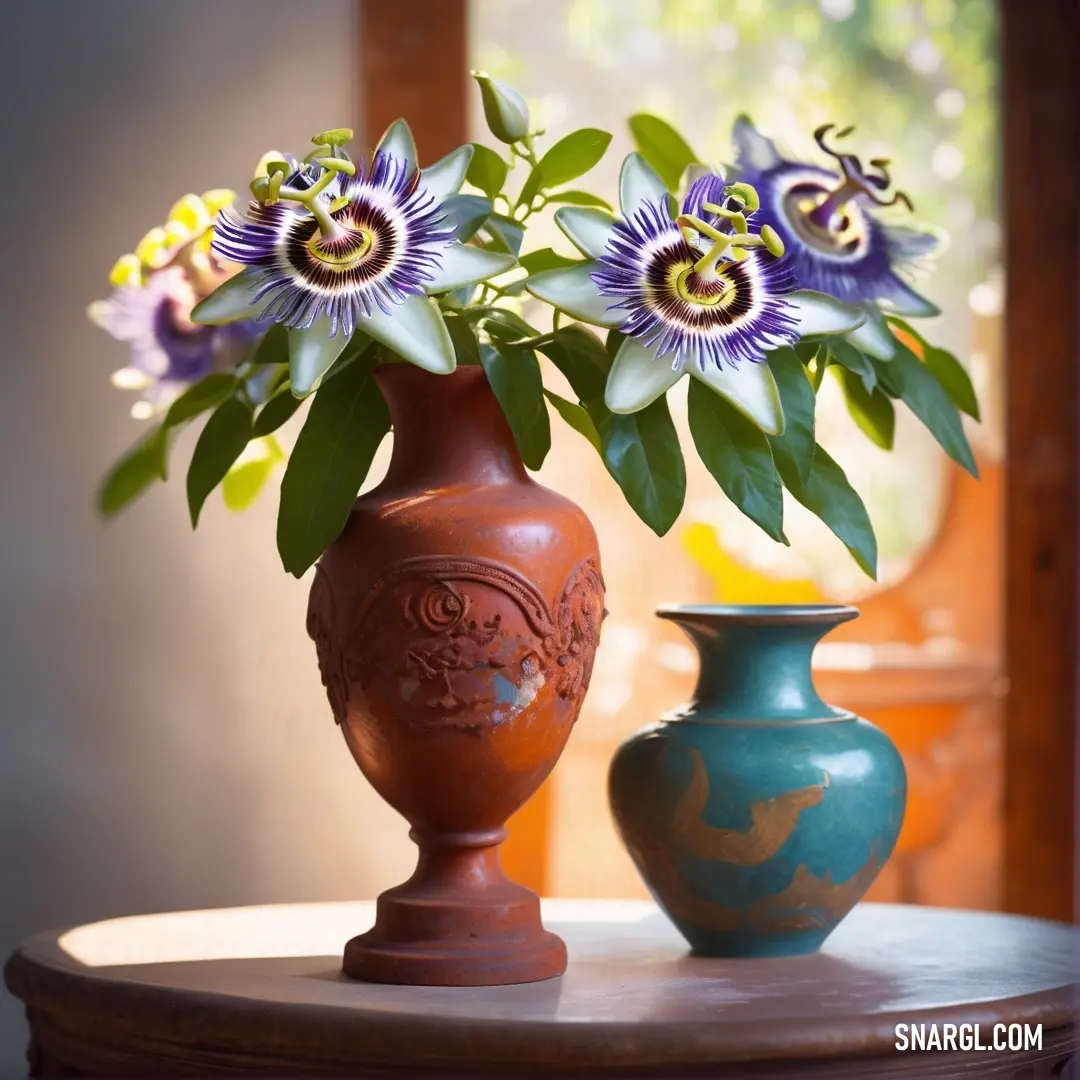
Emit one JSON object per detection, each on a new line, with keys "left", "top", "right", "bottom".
{"left": 658, "top": 605, "right": 858, "bottom": 721}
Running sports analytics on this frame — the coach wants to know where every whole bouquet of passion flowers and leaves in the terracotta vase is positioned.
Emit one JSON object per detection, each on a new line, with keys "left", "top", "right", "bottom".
{"left": 90, "top": 72, "right": 978, "bottom": 577}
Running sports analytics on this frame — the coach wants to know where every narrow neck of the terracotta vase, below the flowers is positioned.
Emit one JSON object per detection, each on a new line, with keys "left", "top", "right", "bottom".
{"left": 375, "top": 364, "right": 529, "bottom": 488}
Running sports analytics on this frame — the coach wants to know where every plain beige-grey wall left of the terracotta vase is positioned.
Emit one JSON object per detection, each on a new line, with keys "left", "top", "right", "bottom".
{"left": 0, "top": 0, "right": 411, "bottom": 1062}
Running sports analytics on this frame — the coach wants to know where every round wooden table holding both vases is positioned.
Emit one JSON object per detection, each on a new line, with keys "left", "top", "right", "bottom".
{"left": 5, "top": 901, "right": 1080, "bottom": 1080}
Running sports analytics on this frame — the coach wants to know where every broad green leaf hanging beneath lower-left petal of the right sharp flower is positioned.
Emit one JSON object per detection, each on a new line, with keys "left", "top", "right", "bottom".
{"left": 586, "top": 397, "right": 686, "bottom": 536}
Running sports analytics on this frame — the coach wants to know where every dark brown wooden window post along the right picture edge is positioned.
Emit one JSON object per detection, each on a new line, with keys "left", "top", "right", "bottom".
{"left": 999, "top": 0, "right": 1080, "bottom": 919}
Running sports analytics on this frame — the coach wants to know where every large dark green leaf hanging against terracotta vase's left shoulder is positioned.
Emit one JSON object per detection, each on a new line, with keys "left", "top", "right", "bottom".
{"left": 278, "top": 353, "right": 390, "bottom": 578}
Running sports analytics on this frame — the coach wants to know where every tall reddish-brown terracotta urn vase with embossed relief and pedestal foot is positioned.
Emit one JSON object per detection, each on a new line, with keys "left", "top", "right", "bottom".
{"left": 308, "top": 364, "right": 604, "bottom": 986}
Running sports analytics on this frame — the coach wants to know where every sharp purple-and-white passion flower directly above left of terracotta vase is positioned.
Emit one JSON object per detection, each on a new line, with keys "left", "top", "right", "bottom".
{"left": 193, "top": 121, "right": 516, "bottom": 394}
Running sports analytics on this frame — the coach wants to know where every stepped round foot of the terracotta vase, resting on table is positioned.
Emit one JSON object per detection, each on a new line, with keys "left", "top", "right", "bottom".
{"left": 341, "top": 881, "right": 566, "bottom": 986}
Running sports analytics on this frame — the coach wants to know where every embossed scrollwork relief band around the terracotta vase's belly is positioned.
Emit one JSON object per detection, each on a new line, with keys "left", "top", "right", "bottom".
{"left": 343, "top": 556, "right": 603, "bottom": 733}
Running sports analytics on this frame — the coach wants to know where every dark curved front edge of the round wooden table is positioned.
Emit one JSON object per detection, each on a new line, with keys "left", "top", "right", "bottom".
{"left": 3, "top": 935, "right": 1080, "bottom": 1067}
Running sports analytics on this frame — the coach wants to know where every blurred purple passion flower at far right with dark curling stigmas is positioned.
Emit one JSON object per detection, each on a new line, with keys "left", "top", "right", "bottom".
{"left": 733, "top": 117, "right": 940, "bottom": 360}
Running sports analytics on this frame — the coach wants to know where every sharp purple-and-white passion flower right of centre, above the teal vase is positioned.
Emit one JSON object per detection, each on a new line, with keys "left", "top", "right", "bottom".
{"left": 526, "top": 153, "right": 864, "bottom": 433}
